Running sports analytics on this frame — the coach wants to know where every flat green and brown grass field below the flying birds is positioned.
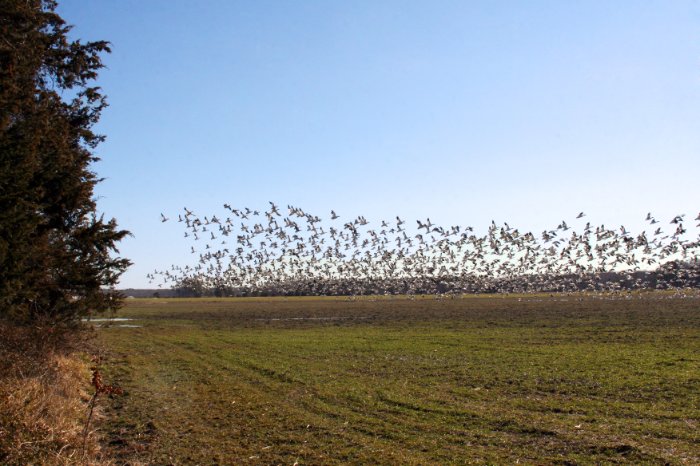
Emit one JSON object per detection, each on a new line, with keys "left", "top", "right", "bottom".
{"left": 99, "top": 294, "right": 700, "bottom": 465}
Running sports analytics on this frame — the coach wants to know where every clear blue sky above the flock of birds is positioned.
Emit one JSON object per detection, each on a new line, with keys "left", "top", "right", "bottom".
{"left": 58, "top": 0, "right": 700, "bottom": 288}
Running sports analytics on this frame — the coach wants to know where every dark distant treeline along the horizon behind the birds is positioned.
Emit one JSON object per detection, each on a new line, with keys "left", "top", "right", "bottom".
{"left": 159, "top": 262, "right": 700, "bottom": 297}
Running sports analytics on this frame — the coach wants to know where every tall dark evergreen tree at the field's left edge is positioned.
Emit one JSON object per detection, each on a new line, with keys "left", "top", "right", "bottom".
{"left": 0, "top": 0, "right": 130, "bottom": 321}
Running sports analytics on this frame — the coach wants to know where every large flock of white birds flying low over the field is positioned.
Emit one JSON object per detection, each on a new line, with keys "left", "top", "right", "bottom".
{"left": 148, "top": 202, "right": 700, "bottom": 296}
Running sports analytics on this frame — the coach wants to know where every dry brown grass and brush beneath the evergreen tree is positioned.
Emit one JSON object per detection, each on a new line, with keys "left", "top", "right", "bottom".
{"left": 0, "top": 323, "right": 104, "bottom": 465}
